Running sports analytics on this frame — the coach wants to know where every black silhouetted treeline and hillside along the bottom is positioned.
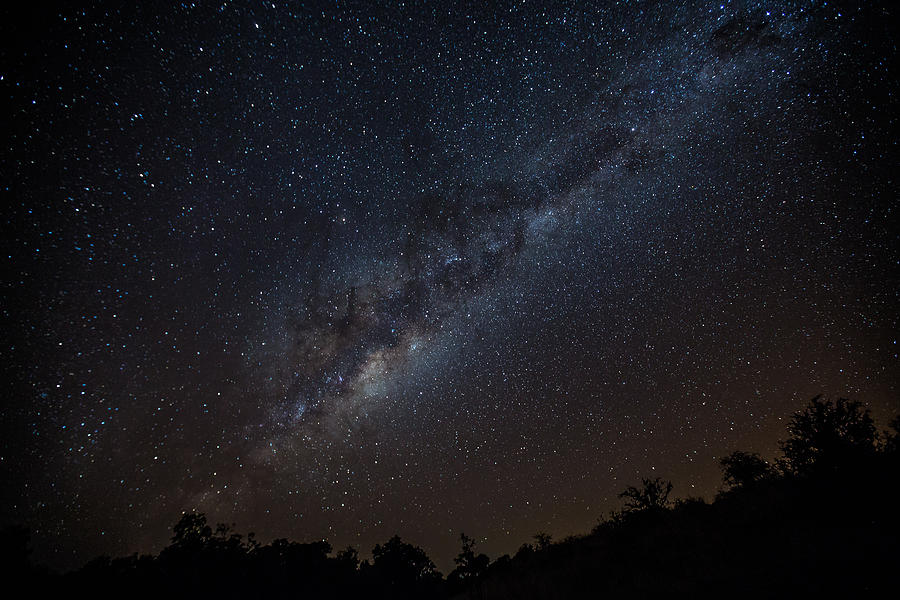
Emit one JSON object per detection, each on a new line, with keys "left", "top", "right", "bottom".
{"left": 0, "top": 397, "right": 900, "bottom": 600}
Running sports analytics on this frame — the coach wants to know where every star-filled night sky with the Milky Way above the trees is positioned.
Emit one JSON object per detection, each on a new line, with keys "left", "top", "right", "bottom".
{"left": 0, "top": 1, "right": 900, "bottom": 573}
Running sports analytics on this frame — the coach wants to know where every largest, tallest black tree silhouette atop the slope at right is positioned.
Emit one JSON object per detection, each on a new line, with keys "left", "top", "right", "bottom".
{"left": 781, "top": 395, "right": 878, "bottom": 474}
